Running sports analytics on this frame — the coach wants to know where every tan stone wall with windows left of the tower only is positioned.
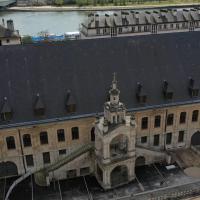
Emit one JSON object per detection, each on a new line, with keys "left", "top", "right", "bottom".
{"left": 0, "top": 118, "right": 94, "bottom": 177}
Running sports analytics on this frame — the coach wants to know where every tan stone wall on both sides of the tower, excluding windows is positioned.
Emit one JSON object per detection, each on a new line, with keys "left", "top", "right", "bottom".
{"left": 0, "top": 104, "right": 200, "bottom": 178}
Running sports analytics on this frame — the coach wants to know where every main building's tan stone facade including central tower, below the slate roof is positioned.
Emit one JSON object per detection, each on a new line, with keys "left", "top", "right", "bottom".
{"left": 0, "top": 78, "right": 200, "bottom": 189}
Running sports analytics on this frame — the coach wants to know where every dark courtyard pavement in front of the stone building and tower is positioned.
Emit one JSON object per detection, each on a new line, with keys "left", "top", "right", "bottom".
{"left": 0, "top": 164, "right": 200, "bottom": 200}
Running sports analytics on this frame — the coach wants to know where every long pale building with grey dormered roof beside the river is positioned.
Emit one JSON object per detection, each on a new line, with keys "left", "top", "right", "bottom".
{"left": 81, "top": 7, "right": 200, "bottom": 38}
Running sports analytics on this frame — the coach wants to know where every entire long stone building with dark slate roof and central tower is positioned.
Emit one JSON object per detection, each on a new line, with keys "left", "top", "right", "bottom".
{"left": 0, "top": 32, "right": 200, "bottom": 189}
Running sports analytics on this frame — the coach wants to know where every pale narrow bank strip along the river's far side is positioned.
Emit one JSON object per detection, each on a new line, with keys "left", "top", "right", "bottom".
{"left": 7, "top": 2, "right": 200, "bottom": 12}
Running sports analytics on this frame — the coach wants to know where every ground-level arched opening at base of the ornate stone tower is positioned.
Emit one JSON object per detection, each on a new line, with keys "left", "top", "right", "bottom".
{"left": 110, "top": 165, "right": 128, "bottom": 187}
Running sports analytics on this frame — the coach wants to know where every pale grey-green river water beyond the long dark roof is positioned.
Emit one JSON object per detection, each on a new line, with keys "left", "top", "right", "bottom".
{"left": 0, "top": 11, "right": 88, "bottom": 35}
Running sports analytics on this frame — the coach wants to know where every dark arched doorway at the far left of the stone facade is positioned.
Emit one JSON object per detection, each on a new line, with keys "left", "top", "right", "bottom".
{"left": 0, "top": 161, "right": 18, "bottom": 177}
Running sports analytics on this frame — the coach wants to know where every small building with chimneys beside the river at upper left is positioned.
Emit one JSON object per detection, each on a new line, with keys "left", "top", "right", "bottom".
{"left": 0, "top": 19, "right": 21, "bottom": 46}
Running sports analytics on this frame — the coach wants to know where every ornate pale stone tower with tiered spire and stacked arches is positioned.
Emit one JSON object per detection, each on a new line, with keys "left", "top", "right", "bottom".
{"left": 95, "top": 73, "right": 136, "bottom": 189}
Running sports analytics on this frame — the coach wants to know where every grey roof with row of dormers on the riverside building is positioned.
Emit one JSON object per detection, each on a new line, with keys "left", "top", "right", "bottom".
{"left": 83, "top": 8, "right": 200, "bottom": 28}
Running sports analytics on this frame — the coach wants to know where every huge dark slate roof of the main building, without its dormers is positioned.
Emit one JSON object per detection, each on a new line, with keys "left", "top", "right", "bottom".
{"left": 0, "top": 32, "right": 200, "bottom": 127}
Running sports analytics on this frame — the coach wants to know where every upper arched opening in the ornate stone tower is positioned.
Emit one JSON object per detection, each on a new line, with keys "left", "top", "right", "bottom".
{"left": 110, "top": 135, "right": 128, "bottom": 157}
